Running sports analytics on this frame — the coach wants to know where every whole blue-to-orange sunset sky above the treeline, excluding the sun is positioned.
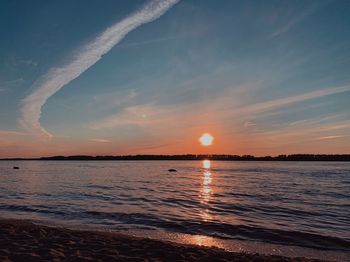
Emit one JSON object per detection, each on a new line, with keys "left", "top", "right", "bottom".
{"left": 0, "top": 0, "right": 350, "bottom": 158}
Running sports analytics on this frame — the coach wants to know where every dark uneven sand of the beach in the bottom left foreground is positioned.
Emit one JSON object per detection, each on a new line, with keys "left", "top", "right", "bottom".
{"left": 0, "top": 220, "right": 317, "bottom": 261}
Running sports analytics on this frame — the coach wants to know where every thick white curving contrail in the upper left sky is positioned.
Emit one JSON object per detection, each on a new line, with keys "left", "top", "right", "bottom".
{"left": 20, "top": 0, "right": 180, "bottom": 137}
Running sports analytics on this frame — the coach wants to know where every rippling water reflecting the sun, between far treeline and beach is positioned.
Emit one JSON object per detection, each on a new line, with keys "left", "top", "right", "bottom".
{"left": 0, "top": 161, "right": 350, "bottom": 252}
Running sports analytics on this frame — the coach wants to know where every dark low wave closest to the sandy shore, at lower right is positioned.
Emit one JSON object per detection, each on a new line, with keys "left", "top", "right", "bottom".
{"left": 85, "top": 211, "right": 350, "bottom": 251}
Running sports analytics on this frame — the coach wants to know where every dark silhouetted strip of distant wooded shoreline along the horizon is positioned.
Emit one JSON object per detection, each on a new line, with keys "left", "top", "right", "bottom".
{"left": 0, "top": 154, "right": 350, "bottom": 162}
